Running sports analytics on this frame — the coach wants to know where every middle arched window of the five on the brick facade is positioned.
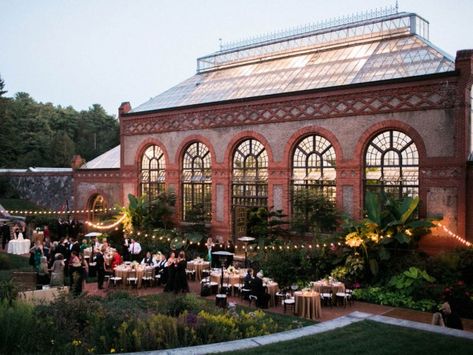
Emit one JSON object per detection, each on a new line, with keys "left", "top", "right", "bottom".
{"left": 232, "top": 139, "right": 268, "bottom": 208}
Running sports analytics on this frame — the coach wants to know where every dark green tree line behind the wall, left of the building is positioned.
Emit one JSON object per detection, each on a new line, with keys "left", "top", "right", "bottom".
{"left": 0, "top": 77, "right": 120, "bottom": 168}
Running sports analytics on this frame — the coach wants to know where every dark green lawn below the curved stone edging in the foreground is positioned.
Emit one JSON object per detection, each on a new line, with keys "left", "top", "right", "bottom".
{"left": 226, "top": 321, "right": 473, "bottom": 355}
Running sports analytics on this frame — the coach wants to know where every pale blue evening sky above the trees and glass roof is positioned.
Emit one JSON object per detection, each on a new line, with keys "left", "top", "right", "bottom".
{"left": 0, "top": 0, "right": 473, "bottom": 115}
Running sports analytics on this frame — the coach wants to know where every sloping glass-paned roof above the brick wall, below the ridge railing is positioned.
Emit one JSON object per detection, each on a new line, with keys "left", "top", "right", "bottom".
{"left": 131, "top": 15, "right": 455, "bottom": 112}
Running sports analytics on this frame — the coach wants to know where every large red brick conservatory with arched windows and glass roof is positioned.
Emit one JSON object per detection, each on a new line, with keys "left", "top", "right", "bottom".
{"left": 74, "top": 10, "right": 473, "bottom": 250}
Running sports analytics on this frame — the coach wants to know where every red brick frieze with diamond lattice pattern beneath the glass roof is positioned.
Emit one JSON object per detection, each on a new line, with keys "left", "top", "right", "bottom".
{"left": 122, "top": 82, "right": 456, "bottom": 135}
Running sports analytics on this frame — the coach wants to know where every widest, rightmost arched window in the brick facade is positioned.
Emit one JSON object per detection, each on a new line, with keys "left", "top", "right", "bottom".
{"left": 365, "top": 130, "right": 419, "bottom": 198}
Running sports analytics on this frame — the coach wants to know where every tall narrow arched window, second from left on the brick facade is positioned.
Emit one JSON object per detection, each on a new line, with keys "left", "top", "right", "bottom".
{"left": 182, "top": 142, "right": 212, "bottom": 222}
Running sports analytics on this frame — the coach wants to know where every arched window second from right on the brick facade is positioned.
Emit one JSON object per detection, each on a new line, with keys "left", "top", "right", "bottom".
{"left": 292, "top": 135, "right": 336, "bottom": 201}
